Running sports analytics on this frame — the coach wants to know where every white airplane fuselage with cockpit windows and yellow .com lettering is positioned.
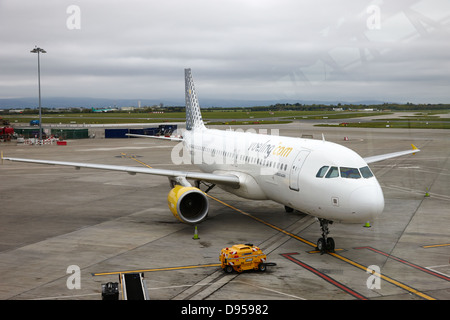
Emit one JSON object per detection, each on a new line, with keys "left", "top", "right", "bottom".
{"left": 184, "top": 128, "right": 384, "bottom": 223}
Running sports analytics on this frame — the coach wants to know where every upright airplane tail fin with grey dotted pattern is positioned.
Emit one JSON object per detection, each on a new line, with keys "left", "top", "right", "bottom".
{"left": 184, "top": 69, "right": 205, "bottom": 130}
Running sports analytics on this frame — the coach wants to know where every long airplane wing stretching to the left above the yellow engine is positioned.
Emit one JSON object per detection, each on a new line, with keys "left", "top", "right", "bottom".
{"left": 2, "top": 155, "right": 239, "bottom": 187}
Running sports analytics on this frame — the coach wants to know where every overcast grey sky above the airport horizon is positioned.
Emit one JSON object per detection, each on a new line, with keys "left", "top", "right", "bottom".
{"left": 0, "top": 0, "right": 450, "bottom": 103}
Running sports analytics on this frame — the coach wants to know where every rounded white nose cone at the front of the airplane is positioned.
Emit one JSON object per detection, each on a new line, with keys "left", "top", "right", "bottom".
{"left": 350, "top": 185, "right": 384, "bottom": 221}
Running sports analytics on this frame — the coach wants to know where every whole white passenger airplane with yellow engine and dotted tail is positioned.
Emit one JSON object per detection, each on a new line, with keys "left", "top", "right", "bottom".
{"left": 2, "top": 69, "right": 420, "bottom": 252}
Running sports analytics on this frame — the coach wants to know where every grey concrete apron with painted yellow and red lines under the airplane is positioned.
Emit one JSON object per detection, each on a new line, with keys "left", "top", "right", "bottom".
{"left": 0, "top": 122, "right": 450, "bottom": 300}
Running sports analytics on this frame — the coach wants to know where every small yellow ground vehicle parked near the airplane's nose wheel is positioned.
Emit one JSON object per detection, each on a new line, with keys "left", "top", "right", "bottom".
{"left": 219, "top": 244, "right": 275, "bottom": 273}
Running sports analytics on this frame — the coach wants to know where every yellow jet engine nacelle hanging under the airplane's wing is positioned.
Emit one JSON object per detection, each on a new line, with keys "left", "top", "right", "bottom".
{"left": 167, "top": 185, "right": 209, "bottom": 224}
